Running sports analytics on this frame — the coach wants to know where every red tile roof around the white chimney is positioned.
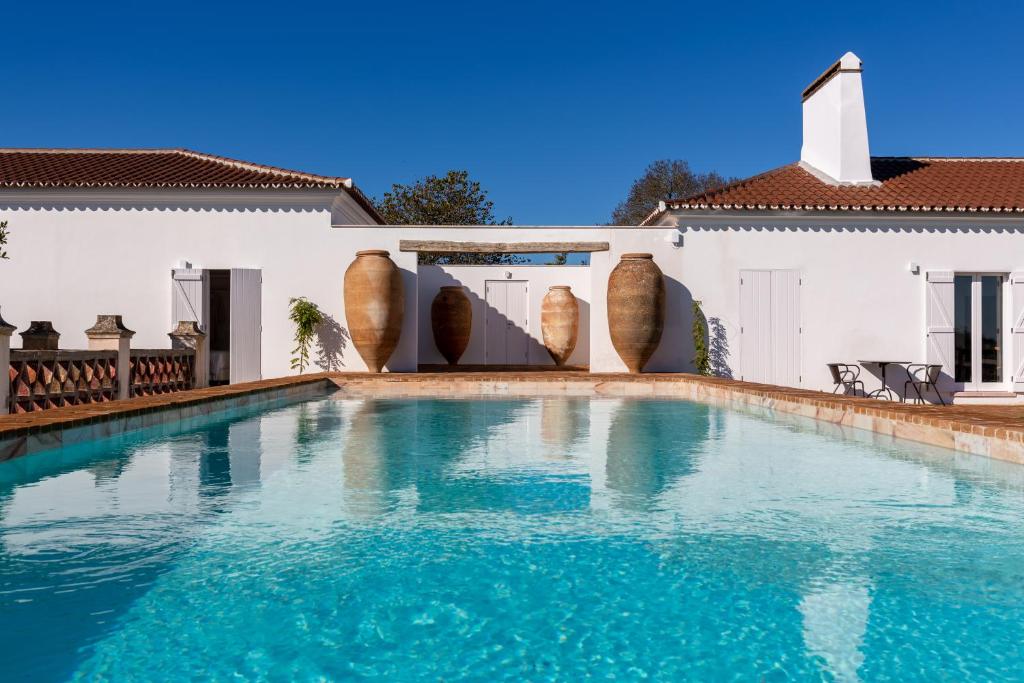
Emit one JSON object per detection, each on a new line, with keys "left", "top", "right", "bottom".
{"left": 644, "top": 157, "right": 1024, "bottom": 223}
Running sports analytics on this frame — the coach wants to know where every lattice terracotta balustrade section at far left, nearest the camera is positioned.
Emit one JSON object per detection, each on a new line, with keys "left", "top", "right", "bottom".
{"left": 8, "top": 349, "right": 118, "bottom": 413}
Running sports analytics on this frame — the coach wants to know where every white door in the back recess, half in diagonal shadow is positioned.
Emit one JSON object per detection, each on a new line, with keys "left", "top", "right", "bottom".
{"left": 483, "top": 280, "right": 529, "bottom": 366}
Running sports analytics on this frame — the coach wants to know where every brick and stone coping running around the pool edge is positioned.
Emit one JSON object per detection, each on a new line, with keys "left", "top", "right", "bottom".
{"left": 0, "top": 371, "right": 1024, "bottom": 463}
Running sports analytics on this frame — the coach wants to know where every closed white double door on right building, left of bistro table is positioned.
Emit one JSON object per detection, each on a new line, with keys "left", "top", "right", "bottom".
{"left": 739, "top": 270, "right": 803, "bottom": 387}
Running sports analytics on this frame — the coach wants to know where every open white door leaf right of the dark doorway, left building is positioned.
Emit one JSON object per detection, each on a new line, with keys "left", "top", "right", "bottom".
{"left": 229, "top": 268, "right": 263, "bottom": 384}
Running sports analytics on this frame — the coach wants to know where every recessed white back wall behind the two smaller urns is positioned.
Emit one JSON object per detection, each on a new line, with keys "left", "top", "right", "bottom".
{"left": 418, "top": 265, "right": 591, "bottom": 366}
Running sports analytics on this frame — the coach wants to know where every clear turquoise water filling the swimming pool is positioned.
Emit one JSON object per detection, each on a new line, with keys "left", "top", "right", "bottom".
{"left": 0, "top": 397, "right": 1024, "bottom": 681}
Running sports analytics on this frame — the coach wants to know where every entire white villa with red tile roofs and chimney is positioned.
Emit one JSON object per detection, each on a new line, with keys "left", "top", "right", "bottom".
{"left": 0, "top": 53, "right": 1024, "bottom": 402}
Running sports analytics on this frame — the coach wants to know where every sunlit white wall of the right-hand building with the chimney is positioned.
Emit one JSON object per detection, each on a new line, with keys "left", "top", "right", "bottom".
{"left": 663, "top": 212, "right": 1024, "bottom": 391}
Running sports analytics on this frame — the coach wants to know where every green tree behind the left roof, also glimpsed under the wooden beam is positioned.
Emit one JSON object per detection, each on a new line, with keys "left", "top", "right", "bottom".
{"left": 377, "top": 171, "right": 522, "bottom": 264}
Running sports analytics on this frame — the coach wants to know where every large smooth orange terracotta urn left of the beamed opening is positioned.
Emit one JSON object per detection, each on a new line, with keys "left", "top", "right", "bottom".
{"left": 345, "top": 249, "right": 406, "bottom": 373}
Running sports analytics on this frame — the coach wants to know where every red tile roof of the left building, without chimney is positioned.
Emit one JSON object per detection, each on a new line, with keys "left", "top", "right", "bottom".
{"left": 0, "top": 148, "right": 383, "bottom": 222}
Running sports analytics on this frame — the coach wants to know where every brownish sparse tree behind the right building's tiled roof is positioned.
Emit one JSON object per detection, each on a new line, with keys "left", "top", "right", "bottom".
{"left": 611, "top": 159, "right": 730, "bottom": 225}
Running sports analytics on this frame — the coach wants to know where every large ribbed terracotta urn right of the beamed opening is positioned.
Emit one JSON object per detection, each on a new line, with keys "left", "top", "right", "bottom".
{"left": 608, "top": 254, "right": 665, "bottom": 373}
